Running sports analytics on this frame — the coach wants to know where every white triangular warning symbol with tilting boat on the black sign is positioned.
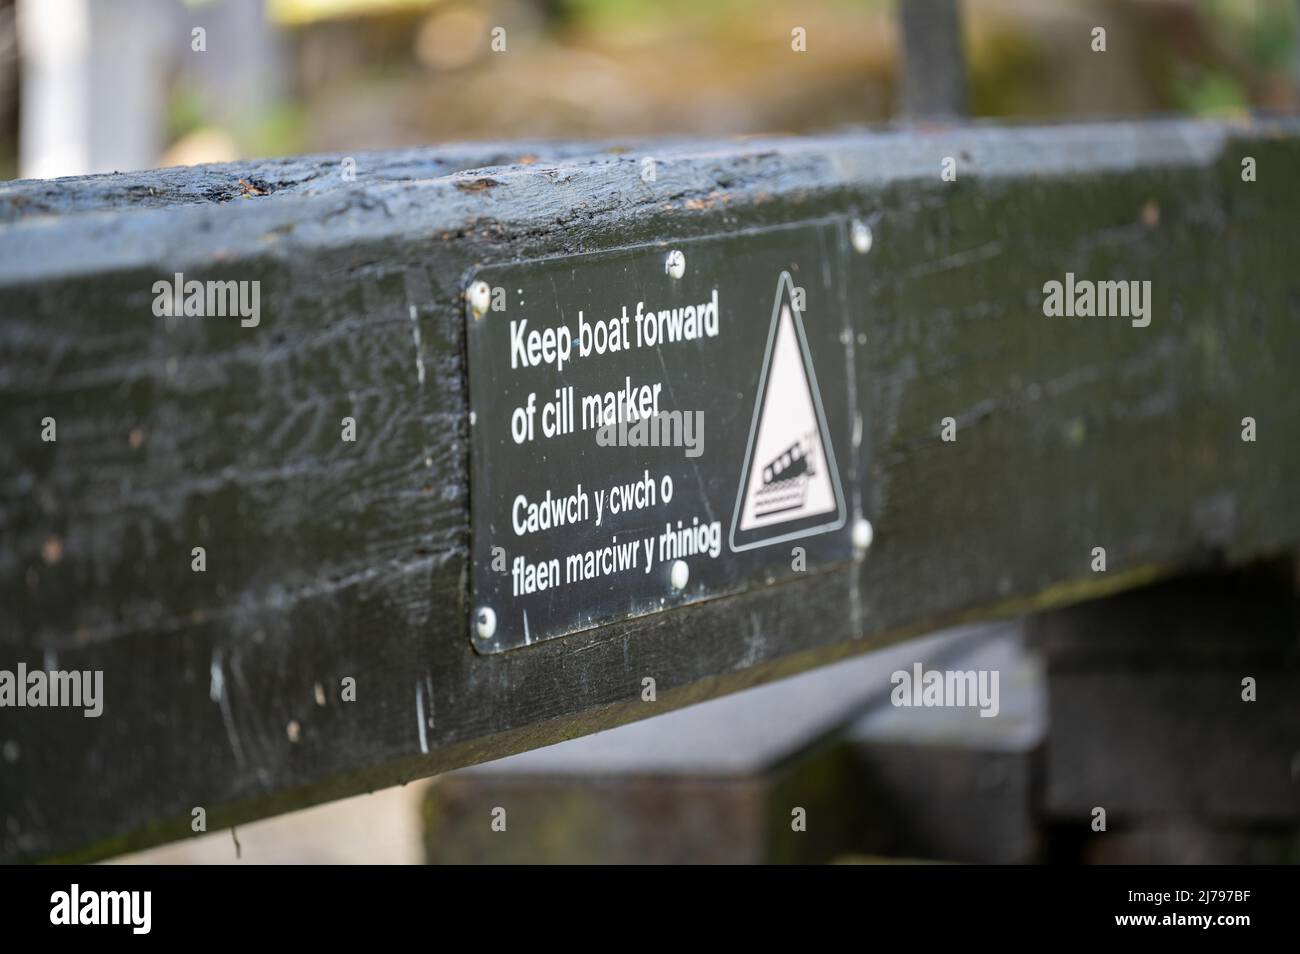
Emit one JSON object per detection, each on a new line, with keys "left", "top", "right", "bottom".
{"left": 731, "top": 272, "right": 845, "bottom": 551}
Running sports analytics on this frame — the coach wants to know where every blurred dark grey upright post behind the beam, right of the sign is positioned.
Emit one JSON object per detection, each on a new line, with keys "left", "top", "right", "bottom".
{"left": 898, "top": 0, "right": 967, "bottom": 120}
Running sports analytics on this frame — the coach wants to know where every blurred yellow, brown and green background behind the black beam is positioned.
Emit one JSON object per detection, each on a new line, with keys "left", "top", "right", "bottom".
{"left": 0, "top": 0, "right": 1300, "bottom": 178}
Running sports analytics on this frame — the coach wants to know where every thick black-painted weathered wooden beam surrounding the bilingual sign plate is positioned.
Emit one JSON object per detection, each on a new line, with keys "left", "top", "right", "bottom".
{"left": 0, "top": 121, "right": 1300, "bottom": 859}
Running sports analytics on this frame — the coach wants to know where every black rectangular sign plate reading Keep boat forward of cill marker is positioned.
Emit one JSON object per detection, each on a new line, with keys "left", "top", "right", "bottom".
{"left": 465, "top": 220, "right": 855, "bottom": 652}
